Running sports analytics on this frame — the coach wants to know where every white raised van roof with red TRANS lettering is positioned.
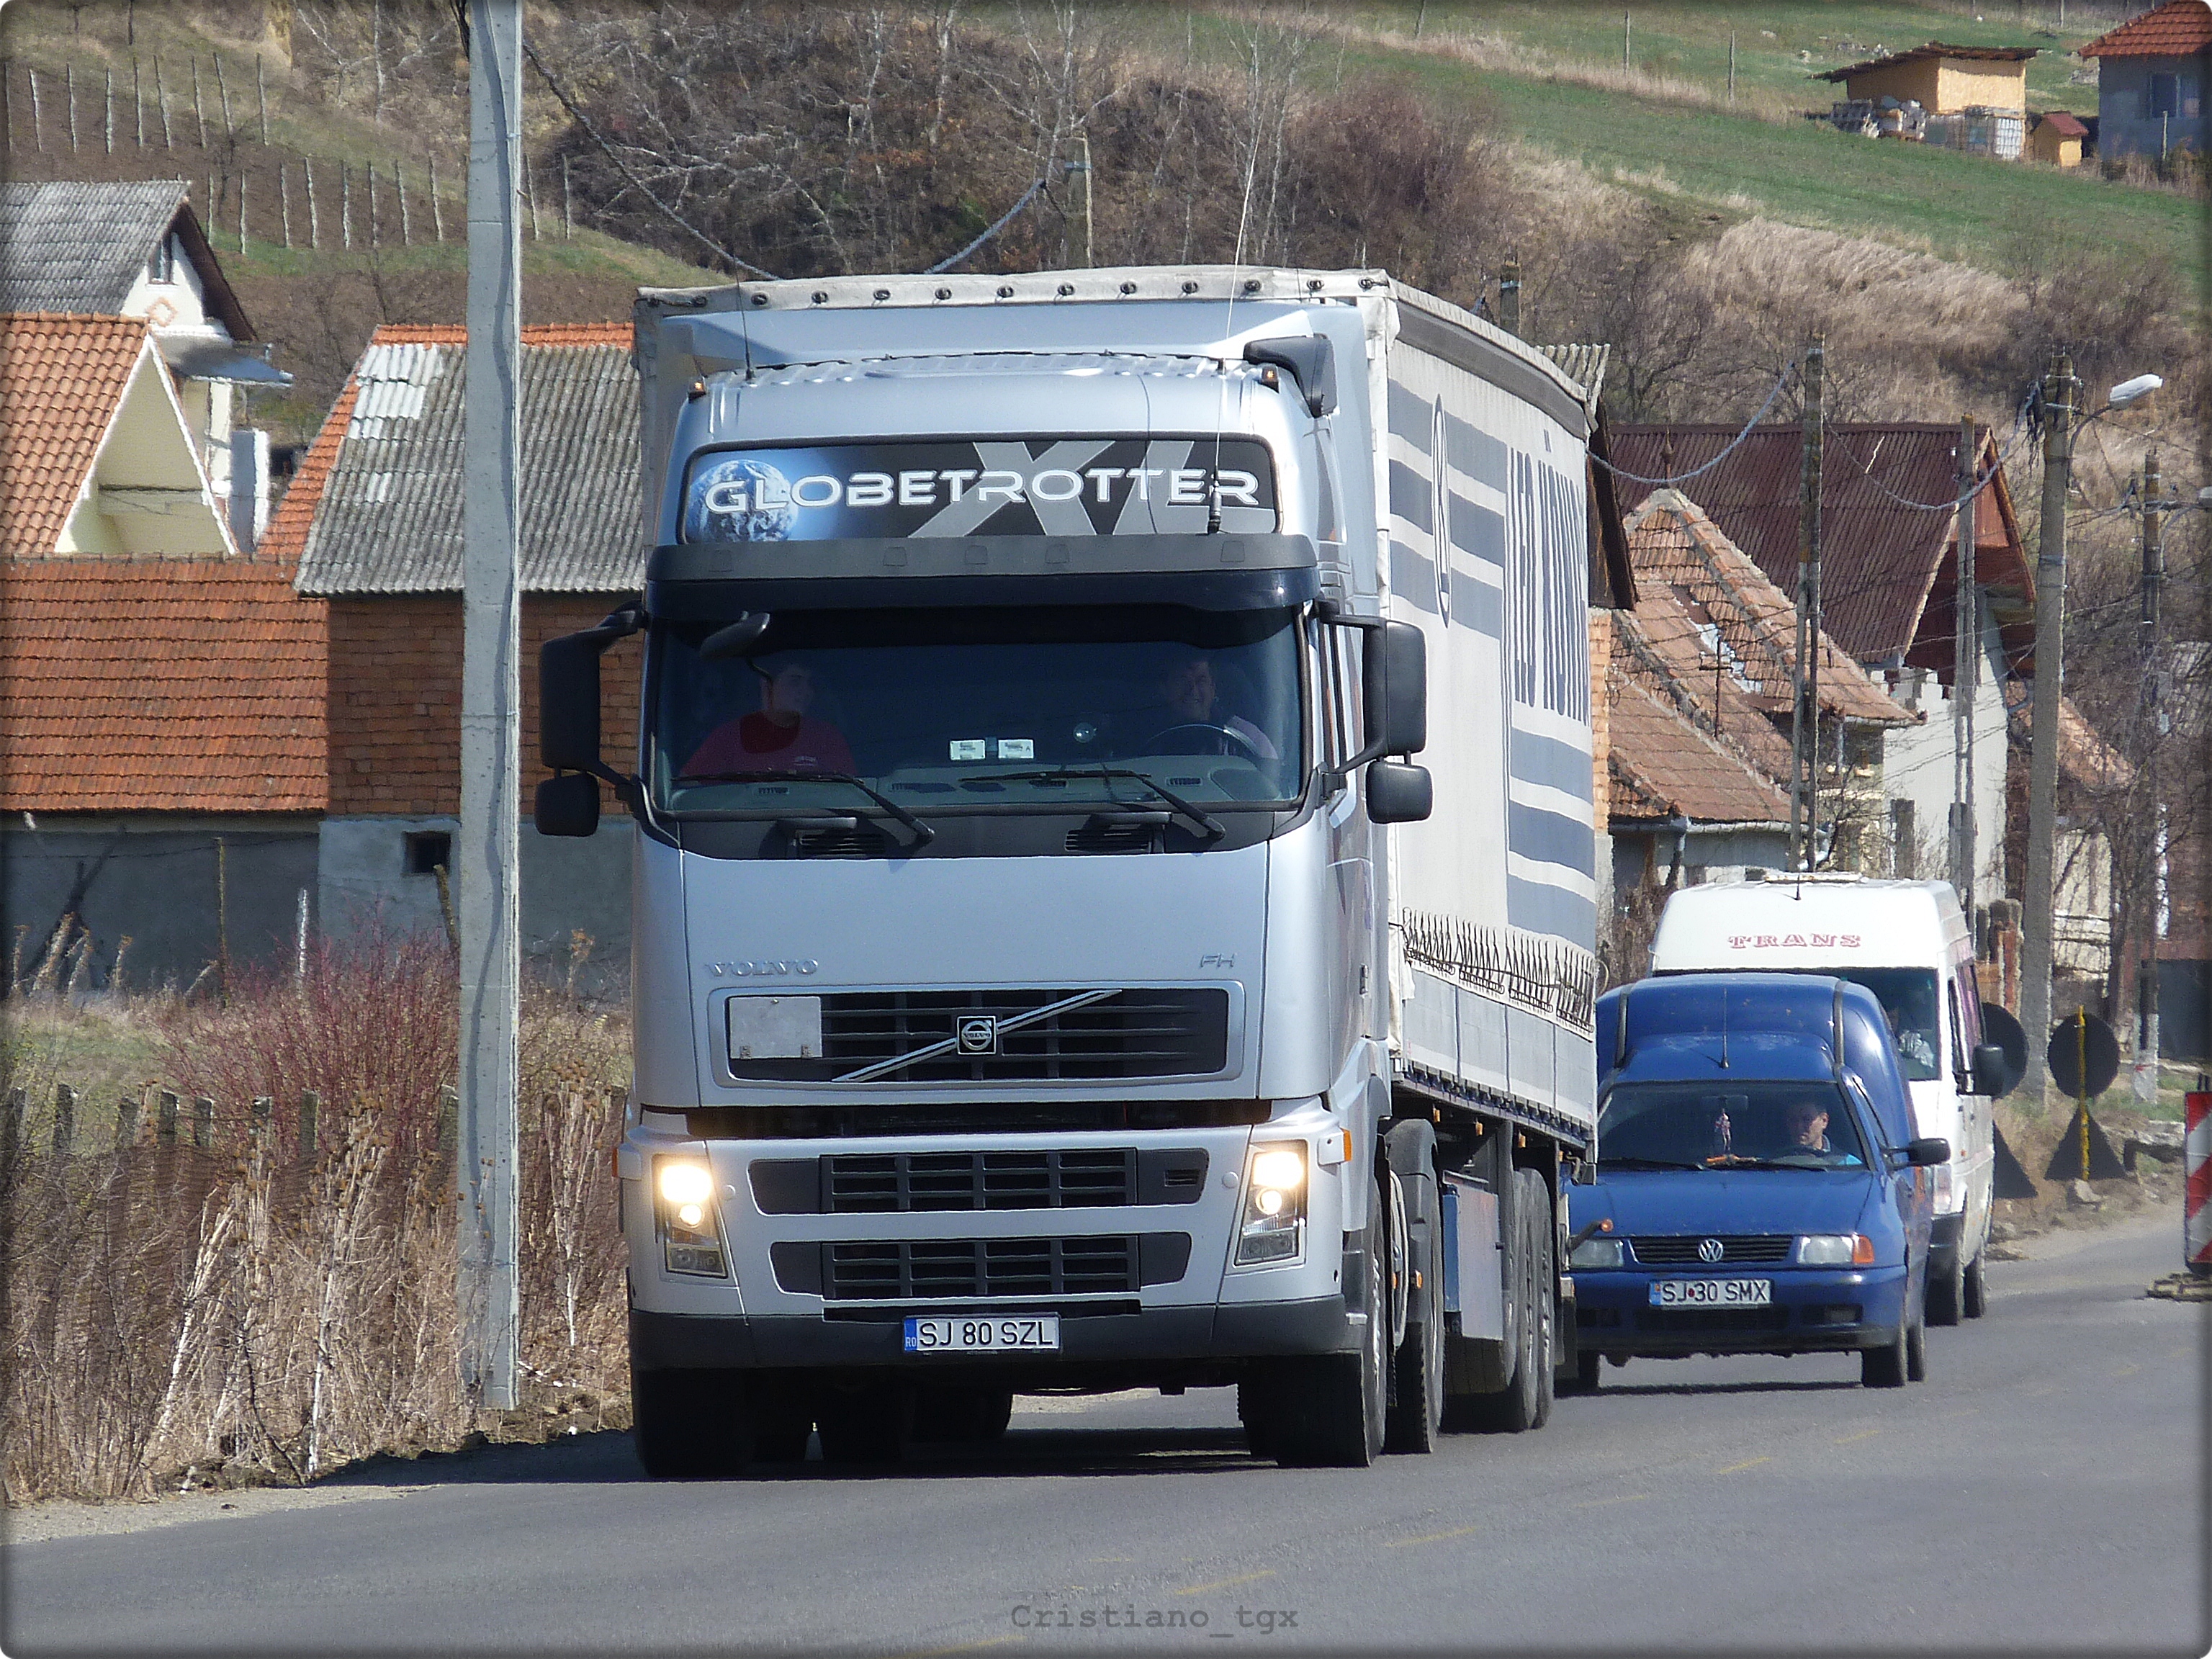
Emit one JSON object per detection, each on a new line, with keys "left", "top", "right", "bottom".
{"left": 1653, "top": 873, "right": 1966, "bottom": 974}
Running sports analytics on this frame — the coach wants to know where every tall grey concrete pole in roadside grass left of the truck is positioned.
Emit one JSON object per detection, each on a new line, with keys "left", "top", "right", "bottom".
{"left": 454, "top": 0, "right": 522, "bottom": 1411}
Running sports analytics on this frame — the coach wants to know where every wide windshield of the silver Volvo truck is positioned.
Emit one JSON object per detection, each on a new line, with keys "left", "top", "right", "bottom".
{"left": 646, "top": 606, "right": 1305, "bottom": 817}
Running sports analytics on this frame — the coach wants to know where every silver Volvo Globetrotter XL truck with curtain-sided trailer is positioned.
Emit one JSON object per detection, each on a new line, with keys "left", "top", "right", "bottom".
{"left": 537, "top": 268, "right": 1599, "bottom": 1475}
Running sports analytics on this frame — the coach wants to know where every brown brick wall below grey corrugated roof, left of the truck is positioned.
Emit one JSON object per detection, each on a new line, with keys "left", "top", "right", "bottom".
{"left": 330, "top": 593, "right": 644, "bottom": 817}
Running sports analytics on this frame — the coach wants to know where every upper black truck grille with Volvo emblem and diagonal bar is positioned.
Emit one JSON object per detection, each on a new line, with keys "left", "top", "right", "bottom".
{"left": 728, "top": 986, "right": 1230, "bottom": 1084}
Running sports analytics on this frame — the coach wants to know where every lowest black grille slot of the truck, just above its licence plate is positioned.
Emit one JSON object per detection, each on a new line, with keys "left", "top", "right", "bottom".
{"left": 770, "top": 1232, "right": 1190, "bottom": 1303}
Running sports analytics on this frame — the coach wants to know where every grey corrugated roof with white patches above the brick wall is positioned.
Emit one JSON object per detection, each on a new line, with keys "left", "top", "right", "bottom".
{"left": 287, "top": 323, "right": 646, "bottom": 595}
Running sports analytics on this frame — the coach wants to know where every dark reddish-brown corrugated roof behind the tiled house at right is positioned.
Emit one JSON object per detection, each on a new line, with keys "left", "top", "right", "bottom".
{"left": 1610, "top": 423, "right": 2035, "bottom": 668}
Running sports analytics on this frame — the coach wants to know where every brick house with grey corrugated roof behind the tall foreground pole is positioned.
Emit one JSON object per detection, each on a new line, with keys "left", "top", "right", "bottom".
{"left": 264, "top": 323, "right": 646, "bottom": 981}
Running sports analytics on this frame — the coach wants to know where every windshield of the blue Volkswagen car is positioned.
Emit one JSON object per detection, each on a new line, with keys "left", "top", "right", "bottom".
{"left": 1597, "top": 1082, "right": 1867, "bottom": 1170}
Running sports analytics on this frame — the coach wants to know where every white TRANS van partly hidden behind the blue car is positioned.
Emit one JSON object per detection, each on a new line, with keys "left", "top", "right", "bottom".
{"left": 1653, "top": 871, "right": 2006, "bottom": 1325}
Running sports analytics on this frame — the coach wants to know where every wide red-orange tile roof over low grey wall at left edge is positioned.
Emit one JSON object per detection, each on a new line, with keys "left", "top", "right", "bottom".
{"left": 0, "top": 557, "right": 330, "bottom": 811}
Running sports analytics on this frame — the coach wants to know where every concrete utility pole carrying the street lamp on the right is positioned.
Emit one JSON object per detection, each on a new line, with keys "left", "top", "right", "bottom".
{"left": 2020, "top": 351, "right": 2075, "bottom": 1104}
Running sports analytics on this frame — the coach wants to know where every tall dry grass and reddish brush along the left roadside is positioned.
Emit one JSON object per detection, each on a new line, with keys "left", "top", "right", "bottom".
{"left": 0, "top": 940, "right": 626, "bottom": 1504}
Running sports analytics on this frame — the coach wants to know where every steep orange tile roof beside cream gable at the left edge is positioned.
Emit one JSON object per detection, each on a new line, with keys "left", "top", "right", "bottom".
{"left": 0, "top": 312, "right": 146, "bottom": 557}
